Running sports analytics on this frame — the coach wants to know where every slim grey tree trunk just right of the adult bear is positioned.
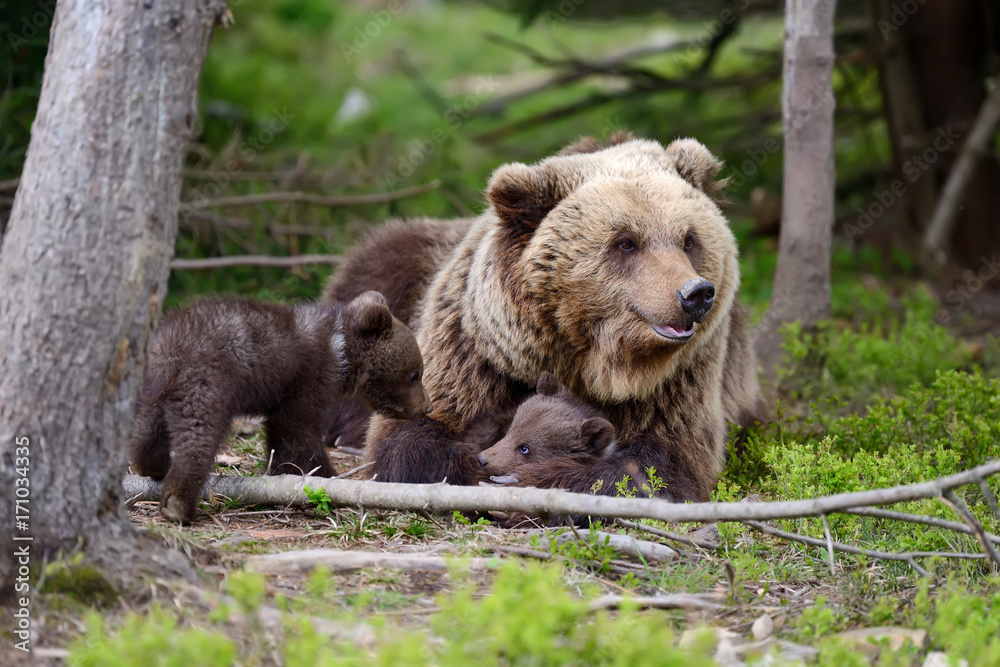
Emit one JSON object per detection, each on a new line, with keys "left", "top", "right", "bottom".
{"left": 756, "top": 0, "right": 836, "bottom": 372}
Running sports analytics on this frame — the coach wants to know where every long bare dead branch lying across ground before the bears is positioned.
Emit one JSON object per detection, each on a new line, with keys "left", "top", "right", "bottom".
{"left": 124, "top": 461, "right": 1000, "bottom": 576}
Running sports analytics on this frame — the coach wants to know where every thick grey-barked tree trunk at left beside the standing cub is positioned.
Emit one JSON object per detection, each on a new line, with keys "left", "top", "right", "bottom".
{"left": 0, "top": 0, "right": 225, "bottom": 594}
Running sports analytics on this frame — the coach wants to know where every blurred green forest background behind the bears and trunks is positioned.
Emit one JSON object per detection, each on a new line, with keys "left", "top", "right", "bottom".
{"left": 0, "top": 0, "right": 1000, "bottom": 326}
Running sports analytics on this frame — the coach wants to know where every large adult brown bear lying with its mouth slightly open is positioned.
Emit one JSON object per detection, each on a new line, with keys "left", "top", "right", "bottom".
{"left": 324, "top": 136, "right": 761, "bottom": 501}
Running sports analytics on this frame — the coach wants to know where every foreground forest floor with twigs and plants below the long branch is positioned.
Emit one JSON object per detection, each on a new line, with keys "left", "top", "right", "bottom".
{"left": 19, "top": 386, "right": 1000, "bottom": 665}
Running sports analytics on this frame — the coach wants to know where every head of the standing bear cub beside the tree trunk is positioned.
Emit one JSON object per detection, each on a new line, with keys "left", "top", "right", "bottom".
{"left": 335, "top": 291, "right": 432, "bottom": 419}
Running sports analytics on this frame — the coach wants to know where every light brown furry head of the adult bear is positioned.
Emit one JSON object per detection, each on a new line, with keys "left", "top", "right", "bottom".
{"left": 471, "top": 137, "right": 739, "bottom": 401}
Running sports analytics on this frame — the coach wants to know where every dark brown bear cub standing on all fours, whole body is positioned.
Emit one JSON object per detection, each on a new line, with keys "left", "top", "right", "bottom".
{"left": 129, "top": 292, "right": 431, "bottom": 522}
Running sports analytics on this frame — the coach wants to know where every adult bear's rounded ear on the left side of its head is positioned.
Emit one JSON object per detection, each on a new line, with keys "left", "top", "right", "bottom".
{"left": 486, "top": 163, "right": 563, "bottom": 237}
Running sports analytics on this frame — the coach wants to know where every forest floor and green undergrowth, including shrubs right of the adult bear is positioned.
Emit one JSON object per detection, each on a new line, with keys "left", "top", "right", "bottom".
{"left": 17, "top": 292, "right": 1000, "bottom": 665}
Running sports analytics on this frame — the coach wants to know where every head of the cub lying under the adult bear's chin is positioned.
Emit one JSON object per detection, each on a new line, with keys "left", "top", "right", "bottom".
{"left": 479, "top": 372, "right": 615, "bottom": 477}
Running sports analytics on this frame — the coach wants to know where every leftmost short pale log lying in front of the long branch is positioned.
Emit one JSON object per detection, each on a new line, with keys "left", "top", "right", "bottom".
{"left": 246, "top": 549, "right": 491, "bottom": 575}
